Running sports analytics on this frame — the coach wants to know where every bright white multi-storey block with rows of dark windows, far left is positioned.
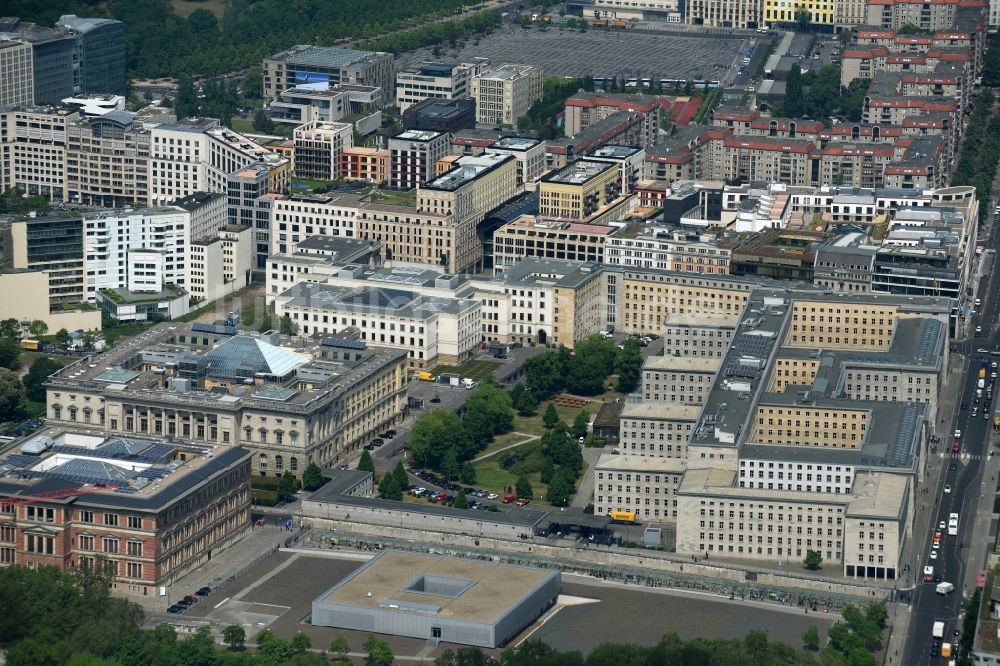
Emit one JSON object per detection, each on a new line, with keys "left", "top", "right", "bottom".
{"left": 84, "top": 206, "right": 192, "bottom": 302}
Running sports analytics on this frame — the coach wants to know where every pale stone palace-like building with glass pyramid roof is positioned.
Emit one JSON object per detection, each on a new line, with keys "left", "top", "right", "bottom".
{"left": 46, "top": 324, "right": 406, "bottom": 476}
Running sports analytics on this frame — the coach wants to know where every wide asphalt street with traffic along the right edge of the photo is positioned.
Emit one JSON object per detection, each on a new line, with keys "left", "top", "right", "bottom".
{"left": 901, "top": 210, "right": 1000, "bottom": 666}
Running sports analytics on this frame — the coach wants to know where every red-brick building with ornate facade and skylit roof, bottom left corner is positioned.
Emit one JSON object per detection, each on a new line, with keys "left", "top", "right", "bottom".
{"left": 0, "top": 430, "right": 251, "bottom": 598}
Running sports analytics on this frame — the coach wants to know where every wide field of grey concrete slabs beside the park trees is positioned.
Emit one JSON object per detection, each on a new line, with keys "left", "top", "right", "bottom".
{"left": 397, "top": 25, "right": 750, "bottom": 80}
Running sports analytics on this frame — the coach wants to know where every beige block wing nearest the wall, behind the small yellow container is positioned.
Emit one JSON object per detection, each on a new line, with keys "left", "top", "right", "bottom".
{"left": 592, "top": 454, "right": 684, "bottom": 523}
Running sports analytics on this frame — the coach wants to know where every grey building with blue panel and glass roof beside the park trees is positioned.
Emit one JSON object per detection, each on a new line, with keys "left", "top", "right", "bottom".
{"left": 262, "top": 44, "right": 393, "bottom": 99}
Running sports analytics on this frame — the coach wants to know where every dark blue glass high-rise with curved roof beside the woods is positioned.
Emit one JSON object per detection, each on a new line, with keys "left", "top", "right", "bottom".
{"left": 56, "top": 14, "right": 128, "bottom": 95}
